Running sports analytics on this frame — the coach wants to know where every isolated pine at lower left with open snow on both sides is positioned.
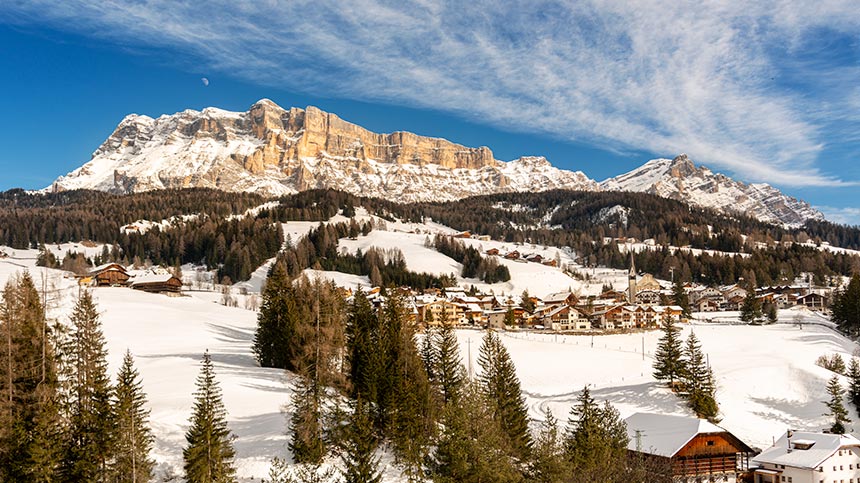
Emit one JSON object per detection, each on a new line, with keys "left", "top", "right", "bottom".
{"left": 182, "top": 350, "right": 236, "bottom": 483}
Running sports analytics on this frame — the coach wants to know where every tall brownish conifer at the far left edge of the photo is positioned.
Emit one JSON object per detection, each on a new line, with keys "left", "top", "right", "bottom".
{"left": 0, "top": 272, "right": 62, "bottom": 481}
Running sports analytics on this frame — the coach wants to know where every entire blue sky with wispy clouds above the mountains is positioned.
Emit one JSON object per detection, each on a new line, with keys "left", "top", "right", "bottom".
{"left": 0, "top": 0, "right": 860, "bottom": 224}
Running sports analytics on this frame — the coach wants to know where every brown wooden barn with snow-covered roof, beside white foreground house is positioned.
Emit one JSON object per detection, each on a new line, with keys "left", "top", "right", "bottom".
{"left": 626, "top": 413, "right": 755, "bottom": 483}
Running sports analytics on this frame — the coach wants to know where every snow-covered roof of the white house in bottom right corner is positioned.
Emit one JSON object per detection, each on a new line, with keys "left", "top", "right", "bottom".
{"left": 753, "top": 431, "right": 860, "bottom": 469}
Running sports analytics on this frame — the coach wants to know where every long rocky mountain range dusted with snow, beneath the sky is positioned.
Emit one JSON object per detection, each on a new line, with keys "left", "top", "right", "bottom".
{"left": 47, "top": 99, "right": 823, "bottom": 226}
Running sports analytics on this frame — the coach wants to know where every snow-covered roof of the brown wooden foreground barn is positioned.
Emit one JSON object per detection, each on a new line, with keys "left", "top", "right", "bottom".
{"left": 625, "top": 413, "right": 726, "bottom": 457}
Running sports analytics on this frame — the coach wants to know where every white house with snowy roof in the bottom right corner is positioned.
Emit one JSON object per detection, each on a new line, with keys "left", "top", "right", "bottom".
{"left": 753, "top": 430, "right": 860, "bottom": 483}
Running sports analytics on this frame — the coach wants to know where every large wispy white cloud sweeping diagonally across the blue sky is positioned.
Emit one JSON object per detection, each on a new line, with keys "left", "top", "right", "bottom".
{"left": 0, "top": 0, "right": 860, "bottom": 186}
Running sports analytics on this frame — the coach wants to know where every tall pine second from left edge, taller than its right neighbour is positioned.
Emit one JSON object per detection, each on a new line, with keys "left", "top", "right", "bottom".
{"left": 63, "top": 291, "right": 116, "bottom": 481}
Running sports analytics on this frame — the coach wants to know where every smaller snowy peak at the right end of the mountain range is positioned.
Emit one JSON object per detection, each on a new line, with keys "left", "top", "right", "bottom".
{"left": 600, "top": 154, "right": 824, "bottom": 226}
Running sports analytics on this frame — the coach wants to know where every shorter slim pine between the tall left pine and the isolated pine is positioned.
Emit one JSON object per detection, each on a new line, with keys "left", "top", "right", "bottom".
{"left": 113, "top": 351, "right": 155, "bottom": 483}
